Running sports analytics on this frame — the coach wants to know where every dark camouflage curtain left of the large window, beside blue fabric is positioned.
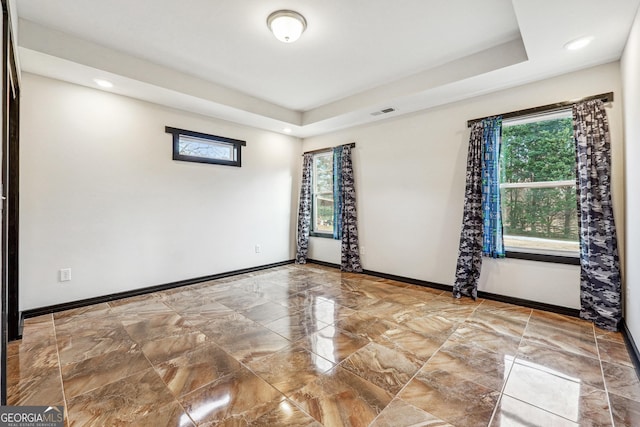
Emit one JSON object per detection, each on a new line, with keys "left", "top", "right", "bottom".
{"left": 453, "top": 122, "right": 484, "bottom": 299}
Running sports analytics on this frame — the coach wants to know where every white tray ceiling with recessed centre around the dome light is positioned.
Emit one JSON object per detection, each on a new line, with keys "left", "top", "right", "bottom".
{"left": 11, "top": 0, "right": 640, "bottom": 137}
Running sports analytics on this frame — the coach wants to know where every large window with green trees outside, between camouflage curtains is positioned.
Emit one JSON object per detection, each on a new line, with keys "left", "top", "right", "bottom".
{"left": 500, "top": 110, "right": 579, "bottom": 257}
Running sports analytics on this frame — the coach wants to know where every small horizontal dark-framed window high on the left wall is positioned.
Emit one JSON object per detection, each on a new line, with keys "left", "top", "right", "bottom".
{"left": 165, "top": 126, "right": 246, "bottom": 167}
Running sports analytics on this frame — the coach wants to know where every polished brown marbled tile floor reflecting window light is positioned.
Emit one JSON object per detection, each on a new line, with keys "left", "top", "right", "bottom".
{"left": 7, "top": 265, "right": 640, "bottom": 427}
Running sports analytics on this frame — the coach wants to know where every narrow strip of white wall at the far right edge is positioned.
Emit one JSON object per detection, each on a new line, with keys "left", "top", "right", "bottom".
{"left": 621, "top": 10, "right": 640, "bottom": 345}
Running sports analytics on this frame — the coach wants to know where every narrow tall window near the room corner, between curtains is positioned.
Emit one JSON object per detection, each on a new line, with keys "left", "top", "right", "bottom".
{"left": 311, "top": 151, "right": 334, "bottom": 237}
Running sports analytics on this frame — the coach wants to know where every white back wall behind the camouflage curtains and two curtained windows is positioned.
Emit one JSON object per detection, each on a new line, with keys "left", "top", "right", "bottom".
{"left": 304, "top": 63, "right": 624, "bottom": 308}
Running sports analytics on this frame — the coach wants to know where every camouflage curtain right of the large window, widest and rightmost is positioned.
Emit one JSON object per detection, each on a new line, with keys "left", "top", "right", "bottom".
{"left": 573, "top": 100, "right": 622, "bottom": 331}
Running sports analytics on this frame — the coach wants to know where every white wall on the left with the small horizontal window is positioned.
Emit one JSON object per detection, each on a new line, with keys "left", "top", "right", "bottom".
{"left": 20, "top": 73, "right": 302, "bottom": 310}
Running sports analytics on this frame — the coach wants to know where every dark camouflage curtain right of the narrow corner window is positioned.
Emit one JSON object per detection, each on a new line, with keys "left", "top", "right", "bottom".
{"left": 338, "top": 145, "right": 362, "bottom": 272}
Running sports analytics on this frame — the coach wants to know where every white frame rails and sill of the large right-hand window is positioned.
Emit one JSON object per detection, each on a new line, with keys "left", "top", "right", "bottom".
{"left": 500, "top": 111, "right": 580, "bottom": 265}
